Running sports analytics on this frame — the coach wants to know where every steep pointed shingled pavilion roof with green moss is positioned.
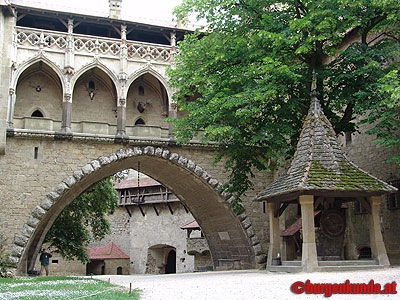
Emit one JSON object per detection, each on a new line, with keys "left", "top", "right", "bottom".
{"left": 255, "top": 85, "right": 396, "bottom": 201}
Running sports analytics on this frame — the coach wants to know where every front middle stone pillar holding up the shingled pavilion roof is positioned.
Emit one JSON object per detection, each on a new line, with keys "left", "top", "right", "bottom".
{"left": 299, "top": 195, "right": 318, "bottom": 272}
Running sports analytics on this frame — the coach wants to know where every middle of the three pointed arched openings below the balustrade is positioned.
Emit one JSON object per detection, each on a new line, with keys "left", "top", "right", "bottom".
{"left": 71, "top": 67, "right": 117, "bottom": 135}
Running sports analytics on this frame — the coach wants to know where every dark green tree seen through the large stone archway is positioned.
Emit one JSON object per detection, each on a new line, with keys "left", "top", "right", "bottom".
{"left": 45, "top": 177, "right": 118, "bottom": 263}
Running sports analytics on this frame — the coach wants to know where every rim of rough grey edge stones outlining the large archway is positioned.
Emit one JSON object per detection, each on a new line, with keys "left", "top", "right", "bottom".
{"left": 10, "top": 146, "right": 265, "bottom": 273}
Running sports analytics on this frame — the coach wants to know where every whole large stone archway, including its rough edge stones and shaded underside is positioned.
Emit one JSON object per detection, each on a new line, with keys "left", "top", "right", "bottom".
{"left": 11, "top": 146, "right": 262, "bottom": 274}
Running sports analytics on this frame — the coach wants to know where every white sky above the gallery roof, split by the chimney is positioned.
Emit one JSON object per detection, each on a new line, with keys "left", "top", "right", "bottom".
{"left": 31, "top": 0, "right": 182, "bottom": 22}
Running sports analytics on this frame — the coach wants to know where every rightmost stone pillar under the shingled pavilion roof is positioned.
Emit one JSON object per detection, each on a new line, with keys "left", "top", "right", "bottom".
{"left": 368, "top": 196, "right": 390, "bottom": 267}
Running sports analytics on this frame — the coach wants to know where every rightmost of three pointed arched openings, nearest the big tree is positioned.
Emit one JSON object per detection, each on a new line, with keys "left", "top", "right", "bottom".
{"left": 126, "top": 73, "right": 169, "bottom": 132}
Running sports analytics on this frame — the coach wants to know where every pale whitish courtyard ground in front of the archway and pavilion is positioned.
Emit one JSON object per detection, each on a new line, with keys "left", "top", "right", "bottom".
{"left": 94, "top": 267, "right": 400, "bottom": 300}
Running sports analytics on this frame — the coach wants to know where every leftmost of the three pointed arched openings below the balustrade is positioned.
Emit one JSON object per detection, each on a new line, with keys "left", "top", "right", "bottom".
{"left": 13, "top": 61, "right": 63, "bottom": 131}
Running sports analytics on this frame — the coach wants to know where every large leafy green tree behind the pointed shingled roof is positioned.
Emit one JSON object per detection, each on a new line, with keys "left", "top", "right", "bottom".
{"left": 168, "top": 0, "right": 400, "bottom": 209}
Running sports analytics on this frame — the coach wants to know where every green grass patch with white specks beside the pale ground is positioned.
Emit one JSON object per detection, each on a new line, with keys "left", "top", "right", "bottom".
{"left": 0, "top": 277, "right": 139, "bottom": 300}
